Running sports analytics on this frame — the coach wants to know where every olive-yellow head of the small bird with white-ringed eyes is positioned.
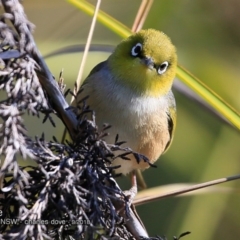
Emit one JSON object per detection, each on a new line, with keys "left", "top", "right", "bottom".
{"left": 108, "top": 29, "right": 177, "bottom": 97}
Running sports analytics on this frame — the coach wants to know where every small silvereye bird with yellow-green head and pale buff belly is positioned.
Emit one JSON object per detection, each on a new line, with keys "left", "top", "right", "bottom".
{"left": 82, "top": 29, "right": 177, "bottom": 178}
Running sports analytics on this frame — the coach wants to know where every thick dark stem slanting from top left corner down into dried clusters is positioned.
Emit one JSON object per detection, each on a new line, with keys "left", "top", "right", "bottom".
{"left": 2, "top": 0, "right": 77, "bottom": 139}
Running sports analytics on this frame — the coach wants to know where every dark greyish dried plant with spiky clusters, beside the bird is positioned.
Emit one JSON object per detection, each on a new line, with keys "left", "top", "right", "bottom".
{"left": 0, "top": 0, "right": 150, "bottom": 239}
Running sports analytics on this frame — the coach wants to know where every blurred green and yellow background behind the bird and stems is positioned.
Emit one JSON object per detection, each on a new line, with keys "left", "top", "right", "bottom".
{"left": 20, "top": 0, "right": 240, "bottom": 240}
